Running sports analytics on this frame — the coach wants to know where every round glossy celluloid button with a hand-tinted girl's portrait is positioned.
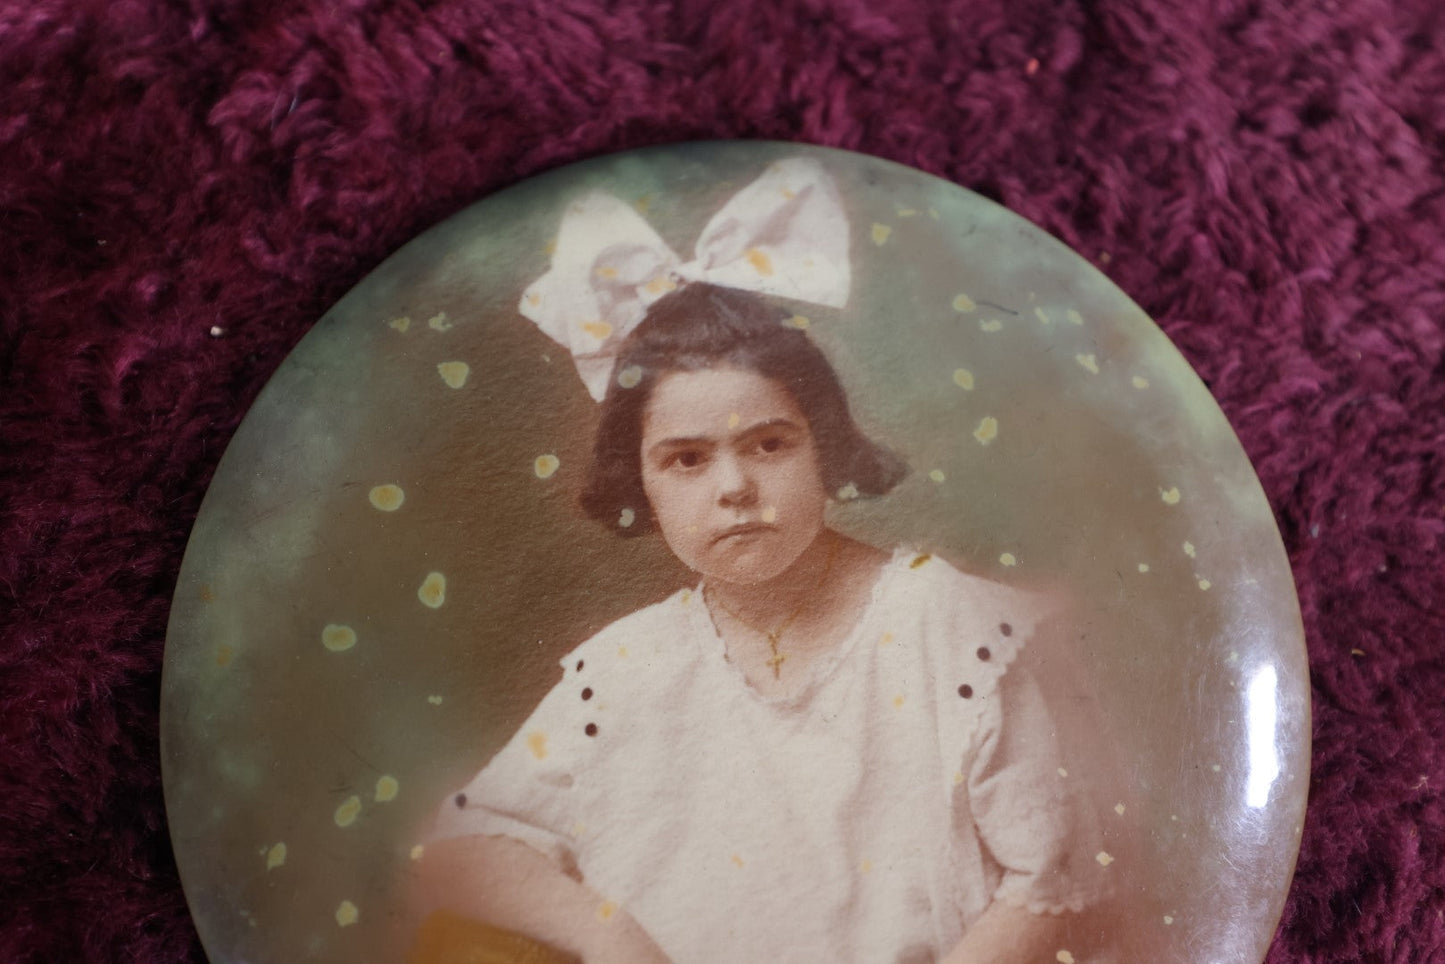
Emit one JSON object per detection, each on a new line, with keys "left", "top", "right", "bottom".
{"left": 163, "top": 143, "right": 1309, "bottom": 963}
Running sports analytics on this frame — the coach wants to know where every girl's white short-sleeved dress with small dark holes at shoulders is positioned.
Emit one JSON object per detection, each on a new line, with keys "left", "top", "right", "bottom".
{"left": 432, "top": 551, "right": 1107, "bottom": 964}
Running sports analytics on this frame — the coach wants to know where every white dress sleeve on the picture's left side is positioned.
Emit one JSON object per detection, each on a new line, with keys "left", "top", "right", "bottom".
{"left": 431, "top": 658, "right": 597, "bottom": 867}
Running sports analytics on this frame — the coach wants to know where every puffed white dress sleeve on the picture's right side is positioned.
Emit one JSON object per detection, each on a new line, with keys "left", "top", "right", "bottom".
{"left": 967, "top": 665, "right": 1107, "bottom": 913}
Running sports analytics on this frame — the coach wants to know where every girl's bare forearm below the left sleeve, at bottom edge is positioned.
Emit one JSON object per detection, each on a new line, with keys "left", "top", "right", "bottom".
{"left": 419, "top": 835, "right": 668, "bottom": 964}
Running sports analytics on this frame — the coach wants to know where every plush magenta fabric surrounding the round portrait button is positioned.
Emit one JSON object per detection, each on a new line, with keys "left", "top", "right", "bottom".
{"left": 0, "top": 0, "right": 1445, "bottom": 964}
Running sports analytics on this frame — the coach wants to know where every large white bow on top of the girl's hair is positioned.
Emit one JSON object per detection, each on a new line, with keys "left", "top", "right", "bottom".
{"left": 519, "top": 158, "right": 850, "bottom": 402}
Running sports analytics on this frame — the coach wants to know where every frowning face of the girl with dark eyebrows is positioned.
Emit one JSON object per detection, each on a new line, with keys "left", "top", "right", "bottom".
{"left": 642, "top": 369, "right": 828, "bottom": 585}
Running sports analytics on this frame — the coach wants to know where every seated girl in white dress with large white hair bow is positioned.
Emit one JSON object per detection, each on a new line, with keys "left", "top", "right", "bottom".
{"left": 426, "top": 159, "right": 1108, "bottom": 964}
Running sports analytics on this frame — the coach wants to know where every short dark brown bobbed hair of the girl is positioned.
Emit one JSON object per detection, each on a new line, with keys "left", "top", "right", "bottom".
{"left": 581, "top": 283, "right": 907, "bottom": 536}
